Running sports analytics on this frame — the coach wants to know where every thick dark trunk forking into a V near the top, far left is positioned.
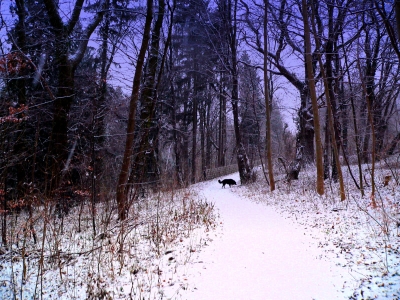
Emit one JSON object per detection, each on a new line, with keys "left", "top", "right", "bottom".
{"left": 44, "top": 0, "right": 105, "bottom": 192}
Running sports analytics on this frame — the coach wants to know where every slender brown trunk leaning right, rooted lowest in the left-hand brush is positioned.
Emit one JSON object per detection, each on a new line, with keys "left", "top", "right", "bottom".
{"left": 116, "top": 0, "right": 153, "bottom": 220}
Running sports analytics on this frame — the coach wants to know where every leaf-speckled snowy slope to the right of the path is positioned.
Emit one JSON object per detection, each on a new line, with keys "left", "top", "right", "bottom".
{"left": 237, "top": 162, "right": 400, "bottom": 299}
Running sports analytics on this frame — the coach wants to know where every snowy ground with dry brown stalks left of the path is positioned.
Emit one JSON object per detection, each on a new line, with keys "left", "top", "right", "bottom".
{"left": 0, "top": 189, "right": 218, "bottom": 299}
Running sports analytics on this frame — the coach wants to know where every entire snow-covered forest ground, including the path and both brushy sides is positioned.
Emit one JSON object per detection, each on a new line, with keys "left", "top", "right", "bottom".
{"left": 0, "top": 164, "right": 400, "bottom": 300}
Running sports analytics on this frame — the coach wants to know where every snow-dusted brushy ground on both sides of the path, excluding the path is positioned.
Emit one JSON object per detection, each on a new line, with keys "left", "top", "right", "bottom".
{"left": 0, "top": 163, "right": 400, "bottom": 299}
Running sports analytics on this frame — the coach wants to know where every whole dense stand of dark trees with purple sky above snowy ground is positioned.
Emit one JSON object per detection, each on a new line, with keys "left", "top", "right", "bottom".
{"left": 0, "top": 0, "right": 400, "bottom": 227}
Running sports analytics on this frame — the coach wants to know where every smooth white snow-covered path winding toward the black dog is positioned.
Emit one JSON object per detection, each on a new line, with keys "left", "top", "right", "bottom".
{"left": 187, "top": 178, "right": 348, "bottom": 300}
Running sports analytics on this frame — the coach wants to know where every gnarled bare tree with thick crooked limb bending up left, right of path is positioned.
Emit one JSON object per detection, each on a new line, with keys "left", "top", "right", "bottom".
{"left": 241, "top": 0, "right": 314, "bottom": 175}
